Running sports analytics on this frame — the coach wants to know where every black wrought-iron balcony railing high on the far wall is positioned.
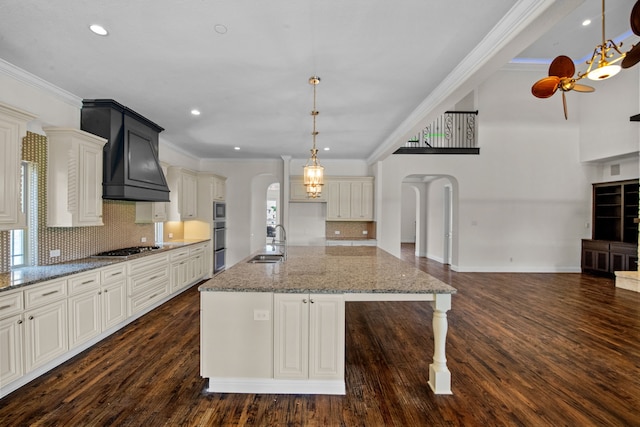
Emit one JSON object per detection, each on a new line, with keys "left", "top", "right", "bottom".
{"left": 394, "top": 111, "right": 480, "bottom": 154}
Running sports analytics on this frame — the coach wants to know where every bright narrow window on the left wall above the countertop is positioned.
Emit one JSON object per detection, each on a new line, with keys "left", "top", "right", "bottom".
{"left": 10, "top": 161, "right": 38, "bottom": 267}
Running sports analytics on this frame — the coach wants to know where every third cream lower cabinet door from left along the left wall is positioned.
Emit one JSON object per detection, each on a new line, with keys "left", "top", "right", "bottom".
{"left": 69, "top": 290, "right": 102, "bottom": 348}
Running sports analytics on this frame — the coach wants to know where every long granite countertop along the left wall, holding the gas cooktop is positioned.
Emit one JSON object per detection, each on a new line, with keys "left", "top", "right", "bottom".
{"left": 0, "top": 239, "right": 209, "bottom": 292}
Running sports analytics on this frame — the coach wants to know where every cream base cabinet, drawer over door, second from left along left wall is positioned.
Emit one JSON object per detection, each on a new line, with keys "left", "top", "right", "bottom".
{"left": 24, "top": 280, "right": 69, "bottom": 372}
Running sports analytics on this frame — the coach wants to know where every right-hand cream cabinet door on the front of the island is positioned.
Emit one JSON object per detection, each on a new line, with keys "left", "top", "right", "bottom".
{"left": 309, "top": 295, "right": 345, "bottom": 380}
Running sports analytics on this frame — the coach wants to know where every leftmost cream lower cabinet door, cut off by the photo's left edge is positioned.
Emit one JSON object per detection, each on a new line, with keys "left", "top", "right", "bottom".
{"left": 0, "top": 314, "right": 24, "bottom": 385}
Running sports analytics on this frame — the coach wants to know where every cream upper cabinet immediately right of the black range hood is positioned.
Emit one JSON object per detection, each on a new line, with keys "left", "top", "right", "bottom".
{"left": 167, "top": 166, "right": 198, "bottom": 221}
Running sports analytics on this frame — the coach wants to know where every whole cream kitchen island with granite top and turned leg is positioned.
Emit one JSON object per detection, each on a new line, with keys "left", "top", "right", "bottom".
{"left": 199, "top": 246, "right": 456, "bottom": 394}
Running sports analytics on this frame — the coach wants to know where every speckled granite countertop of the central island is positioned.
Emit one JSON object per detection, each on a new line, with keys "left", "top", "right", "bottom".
{"left": 198, "top": 246, "right": 456, "bottom": 294}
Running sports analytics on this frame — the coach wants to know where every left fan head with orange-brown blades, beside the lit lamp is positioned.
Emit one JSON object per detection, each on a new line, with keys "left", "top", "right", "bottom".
{"left": 531, "top": 54, "right": 596, "bottom": 120}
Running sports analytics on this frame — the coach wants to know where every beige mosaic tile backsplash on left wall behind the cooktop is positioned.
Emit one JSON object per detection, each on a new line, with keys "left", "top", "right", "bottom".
{"left": 0, "top": 132, "right": 155, "bottom": 272}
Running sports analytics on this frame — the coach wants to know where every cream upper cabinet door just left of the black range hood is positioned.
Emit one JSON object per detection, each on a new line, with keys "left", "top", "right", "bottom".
{"left": 78, "top": 144, "right": 102, "bottom": 225}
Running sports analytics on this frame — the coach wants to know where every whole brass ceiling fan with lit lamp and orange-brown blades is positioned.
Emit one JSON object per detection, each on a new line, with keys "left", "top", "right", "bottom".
{"left": 531, "top": 0, "right": 640, "bottom": 120}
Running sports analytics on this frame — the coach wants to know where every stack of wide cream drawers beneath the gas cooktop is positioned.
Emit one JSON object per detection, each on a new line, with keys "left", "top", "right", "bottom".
{"left": 127, "top": 254, "right": 170, "bottom": 316}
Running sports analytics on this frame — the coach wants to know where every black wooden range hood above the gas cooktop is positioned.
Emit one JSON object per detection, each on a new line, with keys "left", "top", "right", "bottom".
{"left": 80, "top": 99, "right": 169, "bottom": 202}
